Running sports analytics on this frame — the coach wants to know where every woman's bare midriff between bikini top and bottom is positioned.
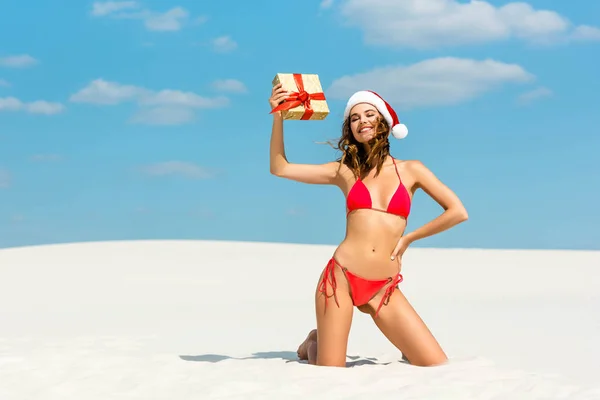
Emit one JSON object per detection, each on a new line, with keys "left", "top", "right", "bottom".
{"left": 334, "top": 209, "right": 406, "bottom": 279}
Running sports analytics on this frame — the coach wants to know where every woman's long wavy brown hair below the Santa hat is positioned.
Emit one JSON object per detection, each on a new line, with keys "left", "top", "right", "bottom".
{"left": 333, "top": 117, "right": 390, "bottom": 178}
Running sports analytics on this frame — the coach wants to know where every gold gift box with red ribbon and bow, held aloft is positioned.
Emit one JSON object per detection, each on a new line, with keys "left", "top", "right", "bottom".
{"left": 271, "top": 74, "right": 329, "bottom": 120}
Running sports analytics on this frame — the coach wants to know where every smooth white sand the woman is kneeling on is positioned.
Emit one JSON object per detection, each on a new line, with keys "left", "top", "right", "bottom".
{"left": 0, "top": 241, "right": 600, "bottom": 400}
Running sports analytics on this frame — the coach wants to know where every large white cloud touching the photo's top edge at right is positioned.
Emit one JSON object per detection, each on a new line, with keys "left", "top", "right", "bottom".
{"left": 332, "top": 0, "right": 597, "bottom": 49}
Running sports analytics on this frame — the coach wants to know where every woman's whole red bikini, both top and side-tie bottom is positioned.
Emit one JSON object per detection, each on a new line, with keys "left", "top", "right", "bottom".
{"left": 319, "top": 157, "right": 411, "bottom": 316}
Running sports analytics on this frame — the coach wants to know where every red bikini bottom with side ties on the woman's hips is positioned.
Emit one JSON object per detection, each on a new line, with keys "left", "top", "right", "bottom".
{"left": 319, "top": 257, "right": 403, "bottom": 316}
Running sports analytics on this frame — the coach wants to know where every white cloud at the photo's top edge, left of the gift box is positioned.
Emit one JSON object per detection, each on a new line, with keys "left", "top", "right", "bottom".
{"left": 92, "top": 1, "right": 193, "bottom": 32}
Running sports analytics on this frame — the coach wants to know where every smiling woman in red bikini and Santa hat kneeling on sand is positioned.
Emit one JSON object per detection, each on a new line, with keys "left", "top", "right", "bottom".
{"left": 269, "top": 84, "right": 468, "bottom": 367}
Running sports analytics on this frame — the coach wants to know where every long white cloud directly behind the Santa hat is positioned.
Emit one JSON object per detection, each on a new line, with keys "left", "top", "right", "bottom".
{"left": 327, "top": 57, "right": 534, "bottom": 109}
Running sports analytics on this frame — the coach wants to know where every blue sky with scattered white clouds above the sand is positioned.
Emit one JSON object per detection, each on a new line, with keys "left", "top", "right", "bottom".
{"left": 0, "top": 0, "right": 600, "bottom": 249}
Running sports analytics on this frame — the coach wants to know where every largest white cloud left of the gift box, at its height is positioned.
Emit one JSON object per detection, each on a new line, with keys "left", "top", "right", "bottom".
{"left": 70, "top": 79, "right": 229, "bottom": 125}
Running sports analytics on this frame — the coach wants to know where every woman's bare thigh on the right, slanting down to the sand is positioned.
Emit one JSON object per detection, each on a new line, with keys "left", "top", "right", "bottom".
{"left": 369, "top": 290, "right": 448, "bottom": 367}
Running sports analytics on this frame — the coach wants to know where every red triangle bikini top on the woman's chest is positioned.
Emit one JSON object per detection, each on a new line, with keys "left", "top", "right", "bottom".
{"left": 346, "top": 157, "right": 410, "bottom": 219}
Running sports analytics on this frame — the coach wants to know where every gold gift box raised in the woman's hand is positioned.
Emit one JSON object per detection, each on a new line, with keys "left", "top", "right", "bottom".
{"left": 273, "top": 74, "right": 329, "bottom": 120}
